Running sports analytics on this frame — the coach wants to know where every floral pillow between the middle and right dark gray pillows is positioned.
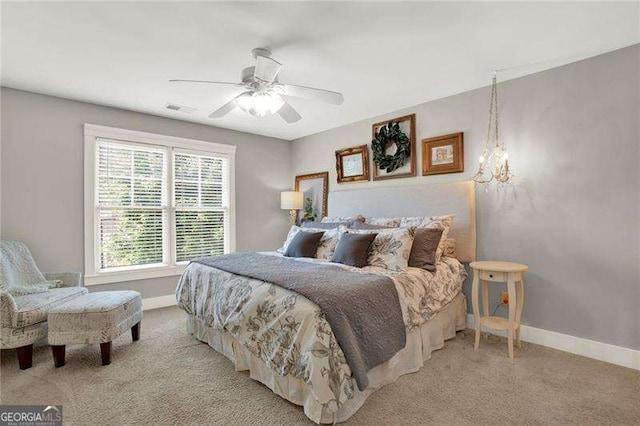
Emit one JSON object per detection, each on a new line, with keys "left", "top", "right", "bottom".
{"left": 350, "top": 227, "right": 415, "bottom": 272}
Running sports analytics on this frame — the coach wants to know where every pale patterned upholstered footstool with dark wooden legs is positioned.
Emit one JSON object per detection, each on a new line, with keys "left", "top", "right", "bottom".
{"left": 47, "top": 291, "right": 142, "bottom": 367}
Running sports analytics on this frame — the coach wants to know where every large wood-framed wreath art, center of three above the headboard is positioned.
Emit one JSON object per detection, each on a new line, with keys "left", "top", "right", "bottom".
{"left": 371, "top": 114, "right": 416, "bottom": 180}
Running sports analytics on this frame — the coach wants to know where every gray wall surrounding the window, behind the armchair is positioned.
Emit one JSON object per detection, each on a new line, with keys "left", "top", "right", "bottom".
{"left": 0, "top": 88, "right": 293, "bottom": 297}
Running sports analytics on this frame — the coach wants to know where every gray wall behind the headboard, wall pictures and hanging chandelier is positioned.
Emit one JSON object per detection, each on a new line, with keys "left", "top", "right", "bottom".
{"left": 292, "top": 45, "right": 640, "bottom": 349}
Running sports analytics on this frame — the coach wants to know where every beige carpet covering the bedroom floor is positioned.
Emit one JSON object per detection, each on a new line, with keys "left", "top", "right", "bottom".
{"left": 0, "top": 308, "right": 640, "bottom": 425}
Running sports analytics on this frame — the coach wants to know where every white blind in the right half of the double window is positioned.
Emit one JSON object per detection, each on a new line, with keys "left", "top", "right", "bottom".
{"left": 173, "top": 150, "right": 229, "bottom": 262}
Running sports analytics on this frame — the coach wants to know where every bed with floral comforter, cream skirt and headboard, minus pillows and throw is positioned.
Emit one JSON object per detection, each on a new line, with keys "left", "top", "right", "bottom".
{"left": 176, "top": 182, "right": 475, "bottom": 423}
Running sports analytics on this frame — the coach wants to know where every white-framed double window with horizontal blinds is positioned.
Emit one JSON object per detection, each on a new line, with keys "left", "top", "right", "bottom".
{"left": 85, "top": 124, "right": 235, "bottom": 284}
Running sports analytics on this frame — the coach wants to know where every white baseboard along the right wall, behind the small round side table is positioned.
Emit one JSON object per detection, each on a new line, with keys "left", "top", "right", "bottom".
{"left": 467, "top": 314, "right": 640, "bottom": 370}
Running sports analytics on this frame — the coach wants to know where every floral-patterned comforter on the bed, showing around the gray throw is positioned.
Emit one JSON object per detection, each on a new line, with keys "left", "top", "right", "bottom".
{"left": 176, "top": 253, "right": 466, "bottom": 411}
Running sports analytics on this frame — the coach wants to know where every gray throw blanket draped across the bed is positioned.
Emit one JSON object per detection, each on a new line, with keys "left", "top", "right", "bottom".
{"left": 194, "top": 253, "right": 407, "bottom": 390}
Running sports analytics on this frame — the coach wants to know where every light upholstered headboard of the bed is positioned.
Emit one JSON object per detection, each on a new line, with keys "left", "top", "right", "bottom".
{"left": 328, "top": 181, "right": 476, "bottom": 262}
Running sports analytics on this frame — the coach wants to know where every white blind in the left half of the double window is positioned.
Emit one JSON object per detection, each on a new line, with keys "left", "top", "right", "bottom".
{"left": 96, "top": 139, "right": 168, "bottom": 270}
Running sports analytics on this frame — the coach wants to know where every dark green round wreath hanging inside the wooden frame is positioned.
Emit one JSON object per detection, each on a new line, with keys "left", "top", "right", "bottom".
{"left": 371, "top": 121, "right": 411, "bottom": 173}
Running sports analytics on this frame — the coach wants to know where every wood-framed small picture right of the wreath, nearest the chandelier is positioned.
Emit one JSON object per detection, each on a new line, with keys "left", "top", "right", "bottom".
{"left": 422, "top": 132, "right": 464, "bottom": 176}
